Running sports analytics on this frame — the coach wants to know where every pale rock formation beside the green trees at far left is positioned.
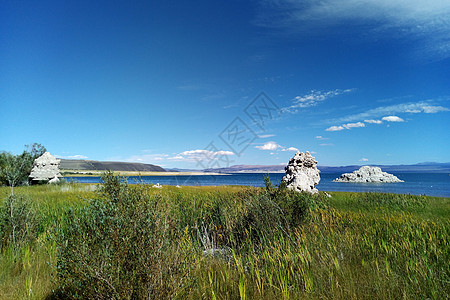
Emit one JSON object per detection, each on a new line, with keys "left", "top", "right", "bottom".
{"left": 30, "top": 152, "right": 62, "bottom": 183}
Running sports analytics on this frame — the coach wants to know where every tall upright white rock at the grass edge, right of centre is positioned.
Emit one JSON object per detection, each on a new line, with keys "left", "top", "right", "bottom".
{"left": 282, "top": 151, "right": 320, "bottom": 194}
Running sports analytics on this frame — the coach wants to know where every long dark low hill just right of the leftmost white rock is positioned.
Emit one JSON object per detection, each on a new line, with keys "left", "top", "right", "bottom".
{"left": 60, "top": 159, "right": 166, "bottom": 172}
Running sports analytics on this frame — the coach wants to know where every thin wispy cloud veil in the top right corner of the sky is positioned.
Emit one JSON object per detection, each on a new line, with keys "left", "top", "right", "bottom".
{"left": 255, "top": 0, "right": 450, "bottom": 59}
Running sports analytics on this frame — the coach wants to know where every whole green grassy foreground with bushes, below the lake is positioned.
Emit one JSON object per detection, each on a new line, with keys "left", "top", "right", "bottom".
{"left": 0, "top": 174, "right": 450, "bottom": 299}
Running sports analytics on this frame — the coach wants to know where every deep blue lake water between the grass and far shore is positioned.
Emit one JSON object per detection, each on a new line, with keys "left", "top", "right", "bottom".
{"left": 66, "top": 173, "right": 450, "bottom": 197}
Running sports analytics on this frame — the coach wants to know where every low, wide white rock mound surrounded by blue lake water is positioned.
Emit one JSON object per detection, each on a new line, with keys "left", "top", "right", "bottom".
{"left": 333, "top": 166, "right": 403, "bottom": 183}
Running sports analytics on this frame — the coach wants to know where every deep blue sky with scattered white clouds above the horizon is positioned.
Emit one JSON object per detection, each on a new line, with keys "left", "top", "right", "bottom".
{"left": 0, "top": 0, "right": 450, "bottom": 168}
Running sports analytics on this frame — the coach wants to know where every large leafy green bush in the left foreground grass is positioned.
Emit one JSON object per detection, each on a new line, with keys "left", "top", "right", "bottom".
{"left": 57, "top": 173, "right": 183, "bottom": 299}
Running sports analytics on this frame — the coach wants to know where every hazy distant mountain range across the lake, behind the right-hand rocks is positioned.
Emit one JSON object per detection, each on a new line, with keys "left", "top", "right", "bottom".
{"left": 203, "top": 162, "right": 450, "bottom": 173}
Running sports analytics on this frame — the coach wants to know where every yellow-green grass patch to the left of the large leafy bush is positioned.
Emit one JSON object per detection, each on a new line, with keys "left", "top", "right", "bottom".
{"left": 0, "top": 184, "right": 94, "bottom": 299}
